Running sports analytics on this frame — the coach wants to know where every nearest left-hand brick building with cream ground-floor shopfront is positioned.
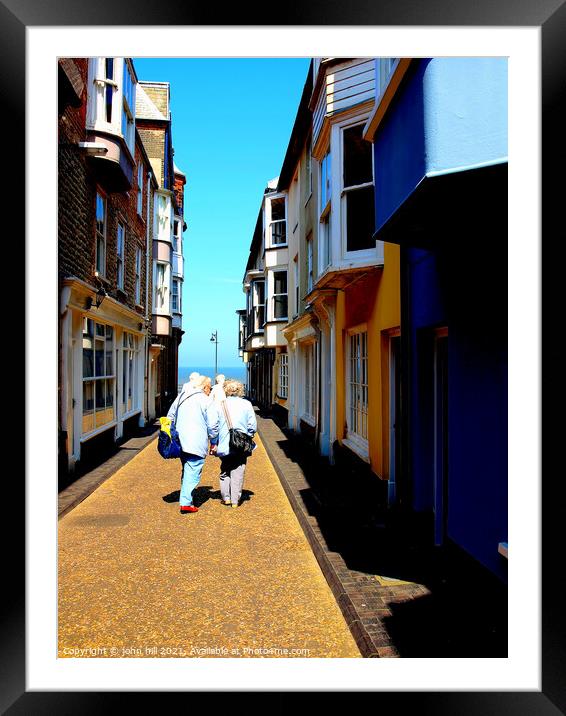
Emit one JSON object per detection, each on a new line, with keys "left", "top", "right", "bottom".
{"left": 58, "top": 58, "right": 156, "bottom": 482}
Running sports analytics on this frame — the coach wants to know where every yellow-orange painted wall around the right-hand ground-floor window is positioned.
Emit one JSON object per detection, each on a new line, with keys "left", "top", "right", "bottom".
{"left": 336, "top": 244, "right": 401, "bottom": 479}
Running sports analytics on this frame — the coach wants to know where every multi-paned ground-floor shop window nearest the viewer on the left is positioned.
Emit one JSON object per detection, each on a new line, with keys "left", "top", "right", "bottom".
{"left": 82, "top": 317, "right": 116, "bottom": 435}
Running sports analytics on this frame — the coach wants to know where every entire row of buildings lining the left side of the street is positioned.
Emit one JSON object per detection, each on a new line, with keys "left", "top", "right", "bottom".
{"left": 58, "top": 57, "right": 189, "bottom": 484}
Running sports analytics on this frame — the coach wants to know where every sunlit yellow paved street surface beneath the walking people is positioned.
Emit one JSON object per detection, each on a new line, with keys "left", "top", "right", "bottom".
{"left": 58, "top": 436, "right": 361, "bottom": 658}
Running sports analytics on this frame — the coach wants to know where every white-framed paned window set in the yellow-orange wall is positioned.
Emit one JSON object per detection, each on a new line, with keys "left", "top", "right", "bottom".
{"left": 343, "top": 323, "right": 369, "bottom": 461}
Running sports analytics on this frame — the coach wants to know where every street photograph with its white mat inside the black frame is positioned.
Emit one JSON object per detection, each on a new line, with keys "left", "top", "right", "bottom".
{"left": 12, "top": 5, "right": 561, "bottom": 716}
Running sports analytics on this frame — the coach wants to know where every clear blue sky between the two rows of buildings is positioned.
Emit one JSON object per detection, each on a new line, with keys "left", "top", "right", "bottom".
{"left": 134, "top": 58, "right": 310, "bottom": 366}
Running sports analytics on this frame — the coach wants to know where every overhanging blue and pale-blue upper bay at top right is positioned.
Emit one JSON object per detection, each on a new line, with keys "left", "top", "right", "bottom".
{"left": 374, "top": 57, "right": 507, "bottom": 229}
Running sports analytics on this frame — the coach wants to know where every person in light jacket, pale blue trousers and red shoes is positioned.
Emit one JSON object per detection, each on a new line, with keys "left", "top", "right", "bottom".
{"left": 167, "top": 375, "right": 218, "bottom": 514}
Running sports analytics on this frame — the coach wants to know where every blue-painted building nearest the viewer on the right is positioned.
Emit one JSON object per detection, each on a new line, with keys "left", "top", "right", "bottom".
{"left": 365, "top": 58, "right": 507, "bottom": 579}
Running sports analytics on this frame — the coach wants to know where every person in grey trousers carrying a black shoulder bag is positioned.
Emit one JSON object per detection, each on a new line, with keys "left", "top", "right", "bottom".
{"left": 211, "top": 380, "right": 257, "bottom": 507}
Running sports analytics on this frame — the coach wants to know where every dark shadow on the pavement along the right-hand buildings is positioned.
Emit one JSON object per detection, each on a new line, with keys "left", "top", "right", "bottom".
{"left": 277, "top": 422, "right": 507, "bottom": 658}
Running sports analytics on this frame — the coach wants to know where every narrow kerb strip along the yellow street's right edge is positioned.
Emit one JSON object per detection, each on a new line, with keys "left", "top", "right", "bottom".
{"left": 258, "top": 416, "right": 381, "bottom": 658}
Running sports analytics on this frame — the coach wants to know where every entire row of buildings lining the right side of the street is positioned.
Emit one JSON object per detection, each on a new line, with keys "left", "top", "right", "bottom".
{"left": 240, "top": 58, "right": 507, "bottom": 579}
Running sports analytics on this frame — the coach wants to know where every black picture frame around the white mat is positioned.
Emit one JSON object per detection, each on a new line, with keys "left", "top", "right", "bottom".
{"left": 7, "top": 0, "right": 566, "bottom": 716}
